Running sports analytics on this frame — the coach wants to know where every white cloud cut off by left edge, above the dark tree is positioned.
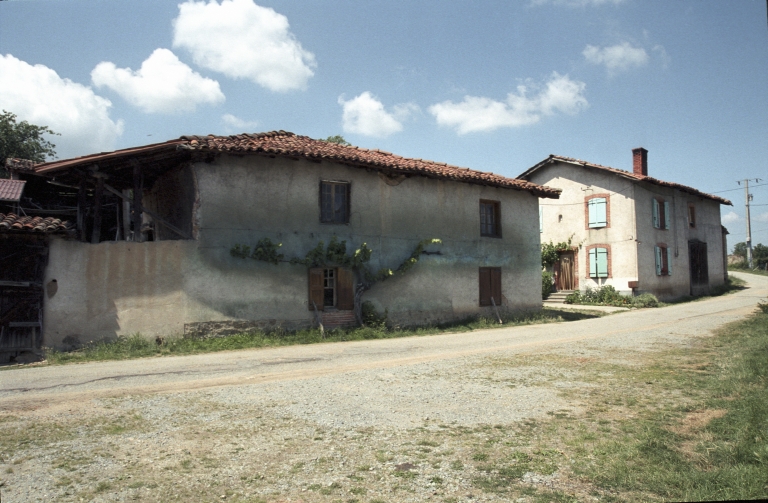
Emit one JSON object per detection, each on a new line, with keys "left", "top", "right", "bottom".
{"left": 0, "top": 54, "right": 123, "bottom": 158}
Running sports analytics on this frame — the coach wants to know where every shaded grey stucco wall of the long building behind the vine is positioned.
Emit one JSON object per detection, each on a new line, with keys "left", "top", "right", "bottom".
{"left": 45, "top": 155, "right": 541, "bottom": 345}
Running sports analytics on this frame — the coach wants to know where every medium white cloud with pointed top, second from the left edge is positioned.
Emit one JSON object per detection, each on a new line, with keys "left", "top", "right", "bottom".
{"left": 91, "top": 49, "right": 224, "bottom": 114}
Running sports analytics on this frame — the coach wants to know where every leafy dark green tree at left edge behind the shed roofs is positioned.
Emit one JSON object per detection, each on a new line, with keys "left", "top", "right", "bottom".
{"left": 0, "top": 110, "right": 58, "bottom": 172}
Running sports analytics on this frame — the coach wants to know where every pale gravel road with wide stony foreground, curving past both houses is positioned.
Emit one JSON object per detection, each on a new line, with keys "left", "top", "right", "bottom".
{"left": 0, "top": 275, "right": 768, "bottom": 502}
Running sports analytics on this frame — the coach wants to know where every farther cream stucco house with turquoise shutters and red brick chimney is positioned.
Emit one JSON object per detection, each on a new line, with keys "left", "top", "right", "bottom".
{"left": 519, "top": 148, "right": 731, "bottom": 299}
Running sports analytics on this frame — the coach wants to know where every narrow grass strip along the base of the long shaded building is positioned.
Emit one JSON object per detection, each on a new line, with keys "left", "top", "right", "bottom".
{"left": 46, "top": 309, "right": 596, "bottom": 365}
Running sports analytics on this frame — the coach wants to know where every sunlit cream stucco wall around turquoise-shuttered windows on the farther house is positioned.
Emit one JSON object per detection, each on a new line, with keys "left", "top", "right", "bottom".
{"left": 530, "top": 163, "right": 637, "bottom": 294}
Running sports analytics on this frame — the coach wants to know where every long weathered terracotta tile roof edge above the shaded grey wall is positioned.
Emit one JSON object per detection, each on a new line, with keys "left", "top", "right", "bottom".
{"left": 178, "top": 131, "right": 560, "bottom": 199}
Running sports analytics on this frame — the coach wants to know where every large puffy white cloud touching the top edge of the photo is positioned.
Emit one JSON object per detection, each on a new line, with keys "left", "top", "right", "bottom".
{"left": 173, "top": 0, "right": 317, "bottom": 91}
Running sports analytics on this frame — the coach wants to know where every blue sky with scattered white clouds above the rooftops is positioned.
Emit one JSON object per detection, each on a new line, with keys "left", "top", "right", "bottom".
{"left": 0, "top": 0, "right": 768, "bottom": 246}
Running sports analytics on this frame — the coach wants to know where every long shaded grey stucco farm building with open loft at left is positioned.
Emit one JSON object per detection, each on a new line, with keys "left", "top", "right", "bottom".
{"left": 4, "top": 131, "right": 560, "bottom": 347}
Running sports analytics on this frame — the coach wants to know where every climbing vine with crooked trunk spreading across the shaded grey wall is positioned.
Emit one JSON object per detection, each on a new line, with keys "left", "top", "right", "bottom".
{"left": 229, "top": 236, "right": 442, "bottom": 324}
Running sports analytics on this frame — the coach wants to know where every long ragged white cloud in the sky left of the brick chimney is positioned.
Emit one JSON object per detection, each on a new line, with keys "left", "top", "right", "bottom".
{"left": 428, "top": 72, "right": 589, "bottom": 134}
